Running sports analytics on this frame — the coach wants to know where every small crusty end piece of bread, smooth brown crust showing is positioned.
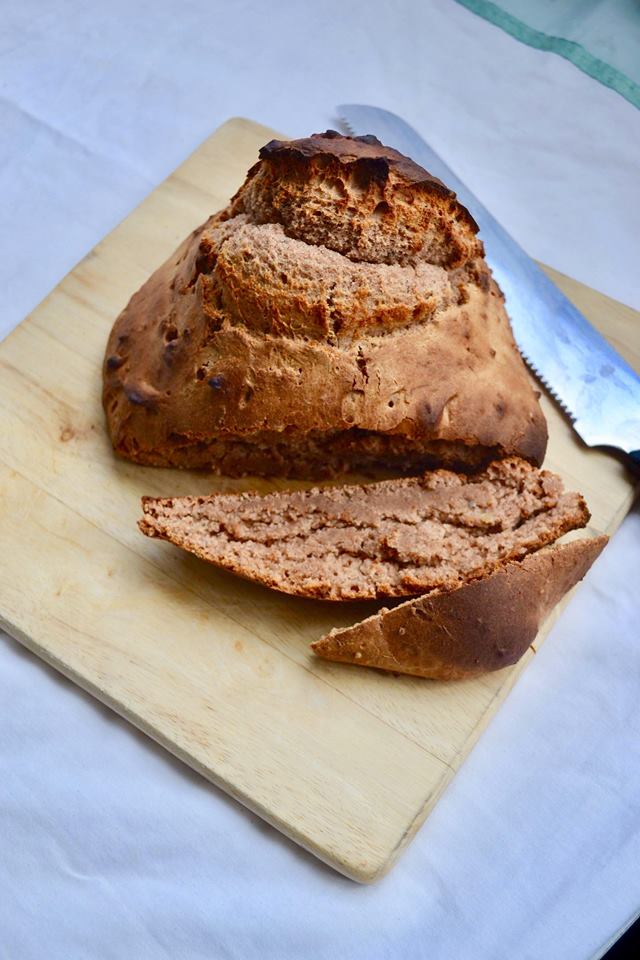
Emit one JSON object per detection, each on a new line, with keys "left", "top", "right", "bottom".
{"left": 311, "top": 537, "right": 607, "bottom": 680}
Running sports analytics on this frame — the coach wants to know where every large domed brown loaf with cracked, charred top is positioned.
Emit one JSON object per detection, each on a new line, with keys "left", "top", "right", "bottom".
{"left": 103, "top": 131, "right": 547, "bottom": 478}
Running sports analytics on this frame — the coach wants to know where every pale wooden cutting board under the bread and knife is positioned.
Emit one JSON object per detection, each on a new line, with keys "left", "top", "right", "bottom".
{"left": 0, "top": 120, "right": 640, "bottom": 881}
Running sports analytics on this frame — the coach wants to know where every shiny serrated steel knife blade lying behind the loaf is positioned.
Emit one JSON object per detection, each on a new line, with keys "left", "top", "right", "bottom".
{"left": 337, "top": 103, "right": 640, "bottom": 463}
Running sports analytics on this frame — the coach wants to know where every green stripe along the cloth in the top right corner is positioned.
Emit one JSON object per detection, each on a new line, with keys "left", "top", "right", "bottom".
{"left": 457, "top": 0, "right": 640, "bottom": 109}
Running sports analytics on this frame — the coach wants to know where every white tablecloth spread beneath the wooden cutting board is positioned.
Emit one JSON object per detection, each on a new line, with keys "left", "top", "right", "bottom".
{"left": 0, "top": 0, "right": 640, "bottom": 960}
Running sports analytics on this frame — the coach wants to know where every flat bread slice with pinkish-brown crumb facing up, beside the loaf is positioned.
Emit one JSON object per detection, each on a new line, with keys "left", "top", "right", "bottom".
{"left": 140, "top": 458, "right": 589, "bottom": 600}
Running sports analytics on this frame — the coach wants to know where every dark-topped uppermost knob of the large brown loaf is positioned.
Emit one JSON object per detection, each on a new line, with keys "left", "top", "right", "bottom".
{"left": 230, "top": 130, "right": 483, "bottom": 268}
